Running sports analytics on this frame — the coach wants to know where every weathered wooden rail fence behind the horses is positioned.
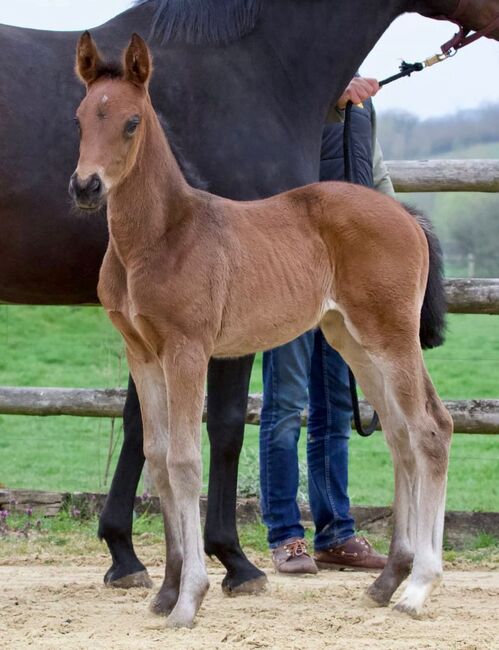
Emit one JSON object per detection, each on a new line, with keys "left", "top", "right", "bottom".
{"left": 0, "top": 160, "right": 499, "bottom": 434}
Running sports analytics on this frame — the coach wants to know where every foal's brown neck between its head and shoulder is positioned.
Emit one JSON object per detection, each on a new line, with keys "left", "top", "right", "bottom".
{"left": 108, "top": 102, "right": 194, "bottom": 264}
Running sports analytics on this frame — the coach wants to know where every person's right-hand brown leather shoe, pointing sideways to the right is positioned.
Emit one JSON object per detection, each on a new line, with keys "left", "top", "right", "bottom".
{"left": 315, "top": 537, "right": 387, "bottom": 571}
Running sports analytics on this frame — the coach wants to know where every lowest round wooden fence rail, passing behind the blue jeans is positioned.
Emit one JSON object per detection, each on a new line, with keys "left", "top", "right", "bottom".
{"left": 0, "top": 386, "right": 499, "bottom": 434}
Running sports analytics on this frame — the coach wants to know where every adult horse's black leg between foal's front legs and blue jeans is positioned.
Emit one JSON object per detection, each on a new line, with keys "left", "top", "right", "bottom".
{"left": 204, "top": 355, "right": 267, "bottom": 595}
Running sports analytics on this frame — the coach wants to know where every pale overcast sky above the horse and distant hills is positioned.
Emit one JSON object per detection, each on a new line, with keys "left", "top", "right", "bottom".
{"left": 0, "top": 0, "right": 499, "bottom": 117}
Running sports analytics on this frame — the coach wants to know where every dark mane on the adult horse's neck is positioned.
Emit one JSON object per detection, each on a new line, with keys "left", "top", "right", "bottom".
{"left": 135, "top": 0, "right": 264, "bottom": 45}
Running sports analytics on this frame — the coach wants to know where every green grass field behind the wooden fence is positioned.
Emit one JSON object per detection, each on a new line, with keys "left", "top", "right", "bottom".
{"left": 0, "top": 306, "right": 499, "bottom": 511}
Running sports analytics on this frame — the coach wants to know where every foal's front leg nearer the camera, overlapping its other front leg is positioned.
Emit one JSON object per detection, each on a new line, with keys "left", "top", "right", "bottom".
{"left": 162, "top": 337, "right": 209, "bottom": 627}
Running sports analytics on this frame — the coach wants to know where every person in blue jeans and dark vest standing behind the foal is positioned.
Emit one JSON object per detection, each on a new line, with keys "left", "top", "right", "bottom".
{"left": 260, "top": 76, "right": 394, "bottom": 574}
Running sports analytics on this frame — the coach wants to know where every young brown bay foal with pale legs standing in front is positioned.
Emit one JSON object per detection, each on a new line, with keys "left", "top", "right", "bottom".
{"left": 70, "top": 33, "right": 452, "bottom": 626}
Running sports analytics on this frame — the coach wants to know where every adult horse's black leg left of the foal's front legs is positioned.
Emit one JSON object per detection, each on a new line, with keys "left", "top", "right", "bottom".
{"left": 98, "top": 377, "right": 152, "bottom": 588}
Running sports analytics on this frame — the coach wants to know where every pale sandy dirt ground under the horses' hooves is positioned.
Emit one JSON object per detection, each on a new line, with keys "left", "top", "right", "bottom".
{"left": 0, "top": 558, "right": 499, "bottom": 650}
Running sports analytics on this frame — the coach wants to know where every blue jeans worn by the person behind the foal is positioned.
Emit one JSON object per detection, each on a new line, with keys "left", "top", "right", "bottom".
{"left": 260, "top": 330, "right": 355, "bottom": 550}
